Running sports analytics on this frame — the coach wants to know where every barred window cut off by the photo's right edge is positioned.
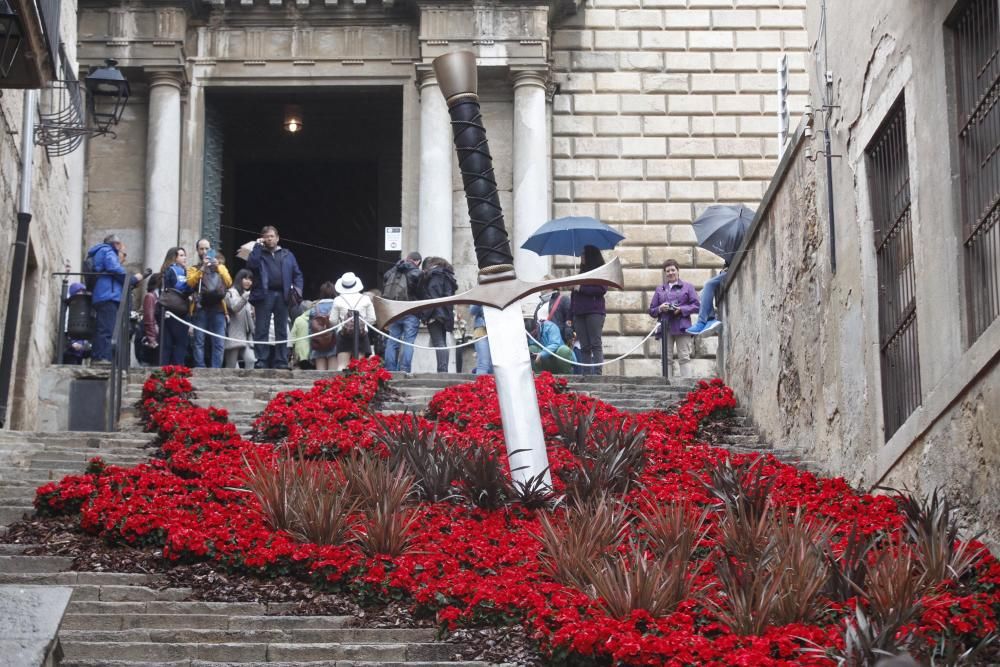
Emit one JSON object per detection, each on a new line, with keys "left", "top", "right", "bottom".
{"left": 948, "top": 0, "right": 1000, "bottom": 341}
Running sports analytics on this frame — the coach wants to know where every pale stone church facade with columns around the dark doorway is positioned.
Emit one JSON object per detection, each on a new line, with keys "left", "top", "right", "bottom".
{"left": 68, "top": 0, "right": 807, "bottom": 374}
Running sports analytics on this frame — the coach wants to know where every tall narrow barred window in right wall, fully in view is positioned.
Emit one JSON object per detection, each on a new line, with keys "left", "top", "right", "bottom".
{"left": 865, "top": 98, "right": 920, "bottom": 440}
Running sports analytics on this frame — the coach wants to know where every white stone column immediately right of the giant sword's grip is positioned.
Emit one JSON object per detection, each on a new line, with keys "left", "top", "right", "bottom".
{"left": 512, "top": 70, "right": 550, "bottom": 281}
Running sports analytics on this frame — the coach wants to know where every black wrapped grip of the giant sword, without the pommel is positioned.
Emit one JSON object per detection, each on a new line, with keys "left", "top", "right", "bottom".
{"left": 448, "top": 96, "right": 514, "bottom": 271}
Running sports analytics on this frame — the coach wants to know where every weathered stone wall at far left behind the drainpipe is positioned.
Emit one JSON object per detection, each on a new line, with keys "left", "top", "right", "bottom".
{"left": 0, "top": 0, "right": 83, "bottom": 428}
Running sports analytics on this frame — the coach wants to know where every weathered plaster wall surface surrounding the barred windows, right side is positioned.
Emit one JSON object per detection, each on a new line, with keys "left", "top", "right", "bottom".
{"left": 721, "top": 0, "right": 1000, "bottom": 544}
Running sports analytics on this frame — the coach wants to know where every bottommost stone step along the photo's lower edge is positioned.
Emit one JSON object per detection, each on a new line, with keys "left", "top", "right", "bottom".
{"left": 60, "top": 640, "right": 455, "bottom": 665}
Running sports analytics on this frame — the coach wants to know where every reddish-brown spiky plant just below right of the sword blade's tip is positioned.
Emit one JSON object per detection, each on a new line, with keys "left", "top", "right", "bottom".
{"left": 536, "top": 496, "right": 626, "bottom": 591}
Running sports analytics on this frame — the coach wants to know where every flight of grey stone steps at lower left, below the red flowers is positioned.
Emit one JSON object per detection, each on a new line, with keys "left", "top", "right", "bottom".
{"left": 0, "top": 544, "right": 487, "bottom": 667}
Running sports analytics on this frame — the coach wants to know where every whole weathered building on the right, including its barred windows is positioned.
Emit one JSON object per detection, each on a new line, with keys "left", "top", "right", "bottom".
{"left": 721, "top": 0, "right": 1000, "bottom": 545}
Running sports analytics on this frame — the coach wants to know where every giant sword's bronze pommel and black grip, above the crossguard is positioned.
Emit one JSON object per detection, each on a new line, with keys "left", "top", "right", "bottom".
{"left": 434, "top": 51, "right": 515, "bottom": 283}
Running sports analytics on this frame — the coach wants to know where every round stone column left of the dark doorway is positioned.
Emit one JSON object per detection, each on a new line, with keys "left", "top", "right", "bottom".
{"left": 144, "top": 72, "right": 183, "bottom": 268}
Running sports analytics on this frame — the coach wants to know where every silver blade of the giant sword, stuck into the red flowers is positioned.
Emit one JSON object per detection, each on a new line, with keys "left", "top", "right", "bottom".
{"left": 483, "top": 304, "right": 552, "bottom": 488}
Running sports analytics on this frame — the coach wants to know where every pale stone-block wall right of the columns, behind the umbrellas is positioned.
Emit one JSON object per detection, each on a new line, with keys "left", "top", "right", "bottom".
{"left": 552, "top": 0, "right": 807, "bottom": 375}
